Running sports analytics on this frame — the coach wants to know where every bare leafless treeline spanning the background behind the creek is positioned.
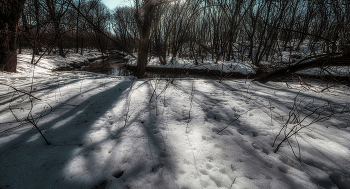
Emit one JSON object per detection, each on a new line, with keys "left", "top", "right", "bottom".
{"left": 19, "top": 0, "right": 350, "bottom": 70}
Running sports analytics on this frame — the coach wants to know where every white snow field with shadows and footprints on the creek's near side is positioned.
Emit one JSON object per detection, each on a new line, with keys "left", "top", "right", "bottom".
{"left": 0, "top": 54, "right": 350, "bottom": 189}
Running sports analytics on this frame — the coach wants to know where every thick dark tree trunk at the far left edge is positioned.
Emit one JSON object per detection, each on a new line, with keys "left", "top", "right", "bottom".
{"left": 0, "top": 0, "right": 25, "bottom": 72}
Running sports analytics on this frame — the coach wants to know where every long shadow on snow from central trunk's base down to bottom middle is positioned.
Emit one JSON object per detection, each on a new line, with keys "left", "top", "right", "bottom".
{"left": 100, "top": 81, "right": 179, "bottom": 188}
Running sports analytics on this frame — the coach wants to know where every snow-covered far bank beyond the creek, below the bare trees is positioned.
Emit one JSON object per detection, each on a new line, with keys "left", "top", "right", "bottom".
{"left": 126, "top": 40, "right": 350, "bottom": 76}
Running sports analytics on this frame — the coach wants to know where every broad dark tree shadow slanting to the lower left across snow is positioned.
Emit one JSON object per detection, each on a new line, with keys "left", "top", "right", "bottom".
{"left": 0, "top": 81, "right": 130, "bottom": 188}
